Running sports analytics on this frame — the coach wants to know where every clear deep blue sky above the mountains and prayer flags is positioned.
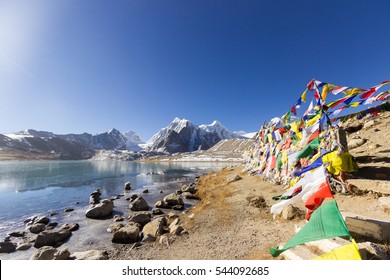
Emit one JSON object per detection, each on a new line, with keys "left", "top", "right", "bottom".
{"left": 0, "top": 0, "right": 390, "bottom": 140}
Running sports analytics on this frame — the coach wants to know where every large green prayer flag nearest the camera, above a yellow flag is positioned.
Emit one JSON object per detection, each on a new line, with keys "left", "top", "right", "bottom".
{"left": 270, "top": 200, "right": 351, "bottom": 257}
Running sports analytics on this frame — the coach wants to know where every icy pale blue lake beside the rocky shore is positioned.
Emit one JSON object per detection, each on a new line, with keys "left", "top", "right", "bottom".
{"left": 0, "top": 161, "right": 232, "bottom": 232}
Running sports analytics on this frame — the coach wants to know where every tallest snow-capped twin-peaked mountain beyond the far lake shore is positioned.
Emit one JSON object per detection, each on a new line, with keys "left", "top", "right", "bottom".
{"left": 145, "top": 118, "right": 242, "bottom": 153}
